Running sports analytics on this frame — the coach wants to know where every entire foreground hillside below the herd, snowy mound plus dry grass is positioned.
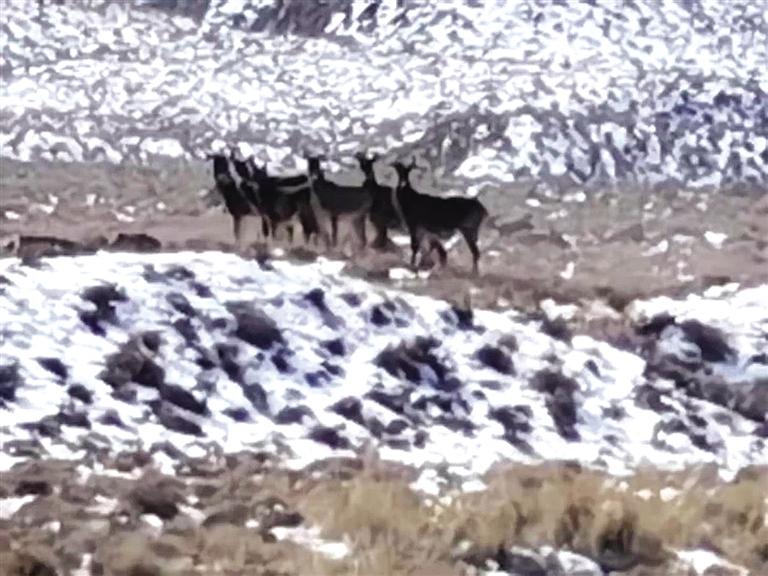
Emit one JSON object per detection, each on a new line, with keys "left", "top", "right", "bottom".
{"left": 0, "top": 252, "right": 768, "bottom": 576}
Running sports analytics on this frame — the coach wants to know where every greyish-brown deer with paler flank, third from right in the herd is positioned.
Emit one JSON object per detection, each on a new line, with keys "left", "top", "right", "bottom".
{"left": 305, "top": 154, "right": 373, "bottom": 248}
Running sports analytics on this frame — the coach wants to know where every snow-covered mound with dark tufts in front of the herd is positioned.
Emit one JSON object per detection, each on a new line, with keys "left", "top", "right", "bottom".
{"left": 0, "top": 252, "right": 768, "bottom": 486}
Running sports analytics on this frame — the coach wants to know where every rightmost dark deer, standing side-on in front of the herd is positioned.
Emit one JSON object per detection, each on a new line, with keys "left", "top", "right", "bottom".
{"left": 391, "top": 157, "right": 488, "bottom": 276}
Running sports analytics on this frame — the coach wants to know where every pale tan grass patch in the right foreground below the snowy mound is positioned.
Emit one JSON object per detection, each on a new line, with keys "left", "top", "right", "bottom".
{"left": 298, "top": 456, "right": 768, "bottom": 574}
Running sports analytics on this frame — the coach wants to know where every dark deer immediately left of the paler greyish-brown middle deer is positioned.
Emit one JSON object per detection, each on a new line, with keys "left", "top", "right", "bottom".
{"left": 247, "top": 157, "right": 319, "bottom": 243}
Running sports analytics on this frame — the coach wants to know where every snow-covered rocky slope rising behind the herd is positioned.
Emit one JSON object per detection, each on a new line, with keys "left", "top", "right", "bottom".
{"left": 0, "top": 0, "right": 768, "bottom": 188}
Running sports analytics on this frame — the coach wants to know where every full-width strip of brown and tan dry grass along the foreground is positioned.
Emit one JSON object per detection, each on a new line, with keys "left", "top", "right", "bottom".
{"left": 0, "top": 458, "right": 768, "bottom": 576}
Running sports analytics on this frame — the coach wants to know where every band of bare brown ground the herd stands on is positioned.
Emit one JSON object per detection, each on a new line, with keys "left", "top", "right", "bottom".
{"left": 0, "top": 159, "right": 768, "bottom": 320}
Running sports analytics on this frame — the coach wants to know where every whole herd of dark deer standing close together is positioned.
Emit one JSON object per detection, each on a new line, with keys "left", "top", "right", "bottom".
{"left": 208, "top": 152, "right": 488, "bottom": 274}
